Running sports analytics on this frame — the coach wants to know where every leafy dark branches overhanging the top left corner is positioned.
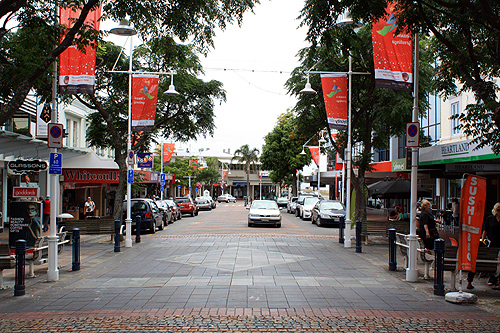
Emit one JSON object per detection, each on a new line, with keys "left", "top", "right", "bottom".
{"left": 0, "top": 0, "right": 259, "bottom": 124}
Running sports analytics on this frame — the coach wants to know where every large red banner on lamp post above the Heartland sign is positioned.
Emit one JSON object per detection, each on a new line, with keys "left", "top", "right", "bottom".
{"left": 372, "top": 3, "right": 413, "bottom": 91}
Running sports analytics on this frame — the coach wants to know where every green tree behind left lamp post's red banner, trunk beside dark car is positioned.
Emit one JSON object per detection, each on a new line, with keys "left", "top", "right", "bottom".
{"left": 76, "top": 38, "right": 225, "bottom": 218}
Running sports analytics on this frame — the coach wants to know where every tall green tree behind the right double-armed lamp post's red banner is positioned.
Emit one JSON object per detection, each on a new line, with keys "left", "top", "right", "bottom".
{"left": 287, "top": 26, "right": 431, "bottom": 219}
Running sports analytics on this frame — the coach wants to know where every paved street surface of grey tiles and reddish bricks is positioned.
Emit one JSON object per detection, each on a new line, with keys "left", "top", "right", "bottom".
{"left": 0, "top": 203, "right": 500, "bottom": 332}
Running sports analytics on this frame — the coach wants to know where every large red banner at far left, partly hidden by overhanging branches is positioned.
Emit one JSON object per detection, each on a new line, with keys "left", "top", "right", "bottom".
{"left": 59, "top": 7, "right": 101, "bottom": 94}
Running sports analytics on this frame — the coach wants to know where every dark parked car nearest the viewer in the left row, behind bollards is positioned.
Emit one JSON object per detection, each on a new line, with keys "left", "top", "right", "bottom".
{"left": 122, "top": 198, "right": 165, "bottom": 234}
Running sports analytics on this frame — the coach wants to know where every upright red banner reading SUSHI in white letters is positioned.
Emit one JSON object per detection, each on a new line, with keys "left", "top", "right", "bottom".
{"left": 458, "top": 175, "right": 486, "bottom": 272}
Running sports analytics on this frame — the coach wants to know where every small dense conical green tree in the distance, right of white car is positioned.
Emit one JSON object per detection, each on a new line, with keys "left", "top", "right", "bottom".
{"left": 260, "top": 111, "right": 311, "bottom": 195}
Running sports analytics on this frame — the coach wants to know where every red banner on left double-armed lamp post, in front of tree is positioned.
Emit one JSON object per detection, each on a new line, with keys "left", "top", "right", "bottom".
{"left": 132, "top": 74, "right": 158, "bottom": 131}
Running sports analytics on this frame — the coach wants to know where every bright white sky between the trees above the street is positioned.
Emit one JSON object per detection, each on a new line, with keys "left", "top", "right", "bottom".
{"left": 181, "top": 0, "right": 307, "bottom": 153}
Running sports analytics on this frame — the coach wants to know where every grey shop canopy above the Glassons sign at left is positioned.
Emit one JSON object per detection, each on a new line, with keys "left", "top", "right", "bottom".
{"left": 0, "top": 130, "right": 91, "bottom": 160}
